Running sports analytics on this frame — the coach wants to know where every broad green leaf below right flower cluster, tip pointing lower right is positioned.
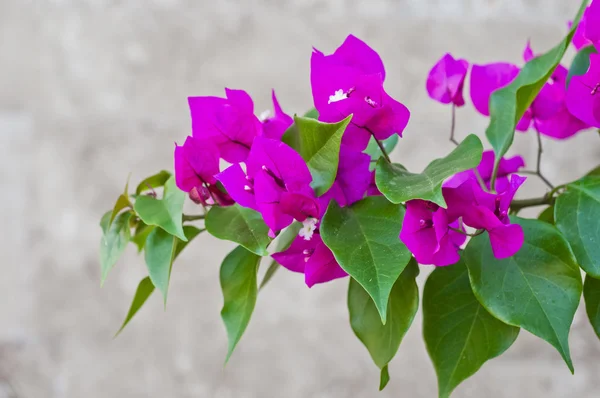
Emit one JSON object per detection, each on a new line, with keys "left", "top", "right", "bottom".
{"left": 464, "top": 217, "right": 582, "bottom": 372}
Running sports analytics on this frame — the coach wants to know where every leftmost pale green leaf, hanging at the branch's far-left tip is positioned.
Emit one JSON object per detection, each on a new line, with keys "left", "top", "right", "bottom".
{"left": 100, "top": 211, "right": 132, "bottom": 286}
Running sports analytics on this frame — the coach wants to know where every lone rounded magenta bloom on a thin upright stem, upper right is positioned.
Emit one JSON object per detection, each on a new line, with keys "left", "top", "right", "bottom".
{"left": 427, "top": 54, "right": 469, "bottom": 106}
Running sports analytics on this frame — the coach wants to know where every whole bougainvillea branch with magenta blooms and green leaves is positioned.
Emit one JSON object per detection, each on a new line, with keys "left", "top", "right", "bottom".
{"left": 100, "top": 0, "right": 600, "bottom": 397}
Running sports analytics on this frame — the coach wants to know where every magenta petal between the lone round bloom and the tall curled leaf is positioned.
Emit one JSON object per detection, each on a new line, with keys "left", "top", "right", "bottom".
{"left": 471, "top": 62, "right": 519, "bottom": 116}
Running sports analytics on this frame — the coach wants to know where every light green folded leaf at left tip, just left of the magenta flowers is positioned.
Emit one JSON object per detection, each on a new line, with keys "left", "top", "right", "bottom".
{"left": 133, "top": 177, "right": 186, "bottom": 241}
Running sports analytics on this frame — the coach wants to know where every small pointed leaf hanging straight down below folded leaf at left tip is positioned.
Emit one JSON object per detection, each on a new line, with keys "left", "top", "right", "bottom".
{"left": 144, "top": 228, "right": 177, "bottom": 305}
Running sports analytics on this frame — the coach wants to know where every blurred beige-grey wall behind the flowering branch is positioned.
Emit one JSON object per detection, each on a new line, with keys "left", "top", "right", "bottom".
{"left": 0, "top": 0, "right": 600, "bottom": 398}
